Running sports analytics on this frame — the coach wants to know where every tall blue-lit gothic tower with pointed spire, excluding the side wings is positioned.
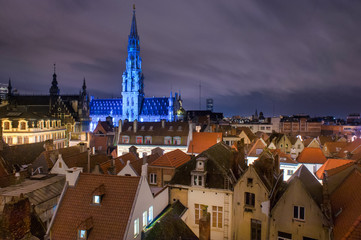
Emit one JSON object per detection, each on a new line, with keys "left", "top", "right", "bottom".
{"left": 122, "top": 6, "right": 144, "bottom": 121}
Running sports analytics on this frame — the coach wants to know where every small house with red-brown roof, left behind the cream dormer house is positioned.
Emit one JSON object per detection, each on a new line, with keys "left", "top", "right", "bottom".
{"left": 148, "top": 149, "right": 191, "bottom": 187}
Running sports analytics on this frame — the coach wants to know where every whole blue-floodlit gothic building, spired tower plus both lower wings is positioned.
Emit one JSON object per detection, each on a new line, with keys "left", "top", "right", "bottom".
{"left": 89, "top": 6, "right": 184, "bottom": 131}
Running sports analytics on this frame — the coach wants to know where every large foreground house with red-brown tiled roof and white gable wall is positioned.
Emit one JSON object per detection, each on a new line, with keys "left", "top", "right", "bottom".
{"left": 47, "top": 167, "right": 168, "bottom": 240}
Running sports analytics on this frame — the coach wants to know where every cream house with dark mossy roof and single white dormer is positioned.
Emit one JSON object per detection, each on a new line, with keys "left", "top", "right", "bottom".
{"left": 169, "top": 142, "right": 246, "bottom": 239}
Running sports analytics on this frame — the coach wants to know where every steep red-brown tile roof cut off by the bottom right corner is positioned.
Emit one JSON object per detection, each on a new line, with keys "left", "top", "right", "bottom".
{"left": 331, "top": 169, "right": 361, "bottom": 239}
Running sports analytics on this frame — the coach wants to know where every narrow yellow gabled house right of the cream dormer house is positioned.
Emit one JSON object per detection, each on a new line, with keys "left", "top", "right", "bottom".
{"left": 230, "top": 151, "right": 283, "bottom": 240}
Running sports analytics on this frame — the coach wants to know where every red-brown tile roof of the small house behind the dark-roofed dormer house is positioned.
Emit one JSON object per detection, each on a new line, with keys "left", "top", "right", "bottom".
{"left": 150, "top": 149, "right": 191, "bottom": 168}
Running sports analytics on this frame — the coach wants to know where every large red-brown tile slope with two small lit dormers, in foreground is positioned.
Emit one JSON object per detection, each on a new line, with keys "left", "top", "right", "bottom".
{"left": 51, "top": 173, "right": 140, "bottom": 240}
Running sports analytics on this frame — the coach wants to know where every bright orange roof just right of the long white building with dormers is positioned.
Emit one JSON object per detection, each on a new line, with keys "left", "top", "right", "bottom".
{"left": 188, "top": 132, "right": 222, "bottom": 153}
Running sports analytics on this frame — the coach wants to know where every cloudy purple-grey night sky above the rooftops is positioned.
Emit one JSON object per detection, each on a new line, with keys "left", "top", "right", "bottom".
{"left": 0, "top": 0, "right": 361, "bottom": 117}
